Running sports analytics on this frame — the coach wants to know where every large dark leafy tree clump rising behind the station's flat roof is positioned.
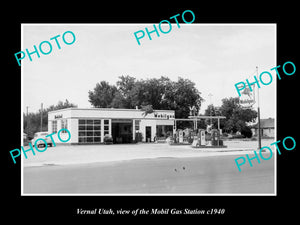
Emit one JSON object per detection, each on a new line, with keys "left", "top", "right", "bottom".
{"left": 89, "top": 75, "right": 203, "bottom": 124}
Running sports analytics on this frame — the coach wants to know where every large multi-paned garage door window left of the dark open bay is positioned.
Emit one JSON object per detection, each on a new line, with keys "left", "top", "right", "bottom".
{"left": 78, "top": 120, "right": 101, "bottom": 143}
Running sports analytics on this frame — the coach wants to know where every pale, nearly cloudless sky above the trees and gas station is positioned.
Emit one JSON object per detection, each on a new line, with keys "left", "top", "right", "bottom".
{"left": 21, "top": 22, "right": 277, "bottom": 118}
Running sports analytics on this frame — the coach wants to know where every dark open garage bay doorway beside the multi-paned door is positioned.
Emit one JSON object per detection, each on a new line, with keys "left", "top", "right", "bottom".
{"left": 111, "top": 119, "right": 133, "bottom": 144}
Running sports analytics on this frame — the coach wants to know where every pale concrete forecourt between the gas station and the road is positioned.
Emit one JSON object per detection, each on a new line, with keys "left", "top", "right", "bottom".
{"left": 22, "top": 140, "right": 273, "bottom": 167}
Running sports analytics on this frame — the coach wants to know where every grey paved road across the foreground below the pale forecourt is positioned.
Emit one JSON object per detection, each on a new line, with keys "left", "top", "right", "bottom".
{"left": 23, "top": 155, "right": 274, "bottom": 194}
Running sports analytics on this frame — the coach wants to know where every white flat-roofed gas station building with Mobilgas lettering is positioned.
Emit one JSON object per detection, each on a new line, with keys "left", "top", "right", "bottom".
{"left": 48, "top": 108, "right": 175, "bottom": 144}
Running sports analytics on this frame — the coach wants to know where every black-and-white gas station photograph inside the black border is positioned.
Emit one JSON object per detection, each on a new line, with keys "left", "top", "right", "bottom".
{"left": 20, "top": 23, "right": 276, "bottom": 195}
